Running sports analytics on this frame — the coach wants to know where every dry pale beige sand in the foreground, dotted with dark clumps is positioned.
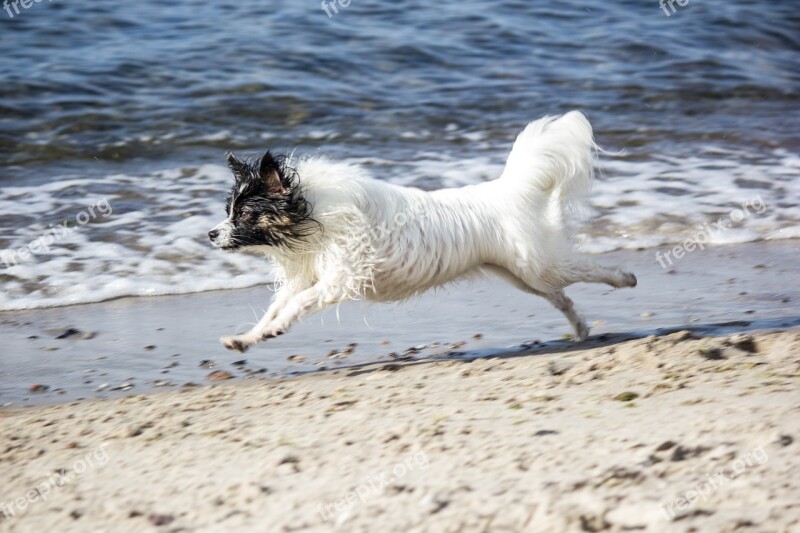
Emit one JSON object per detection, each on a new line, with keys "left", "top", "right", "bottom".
{"left": 0, "top": 329, "right": 800, "bottom": 532}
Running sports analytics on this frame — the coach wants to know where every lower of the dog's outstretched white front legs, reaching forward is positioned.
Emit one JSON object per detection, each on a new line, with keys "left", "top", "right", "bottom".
{"left": 222, "top": 285, "right": 338, "bottom": 352}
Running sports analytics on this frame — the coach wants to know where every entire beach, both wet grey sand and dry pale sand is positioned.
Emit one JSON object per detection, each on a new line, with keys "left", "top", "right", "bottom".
{"left": 0, "top": 241, "right": 800, "bottom": 531}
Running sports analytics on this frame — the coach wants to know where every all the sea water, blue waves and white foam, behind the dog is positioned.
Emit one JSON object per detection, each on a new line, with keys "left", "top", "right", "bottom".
{"left": 0, "top": 0, "right": 800, "bottom": 310}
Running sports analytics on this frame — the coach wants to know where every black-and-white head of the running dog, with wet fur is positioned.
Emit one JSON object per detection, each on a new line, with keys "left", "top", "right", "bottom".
{"left": 208, "top": 151, "right": 319, "bottom": 251}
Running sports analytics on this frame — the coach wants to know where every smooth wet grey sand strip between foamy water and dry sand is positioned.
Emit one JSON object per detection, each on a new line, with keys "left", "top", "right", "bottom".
{"left": 0, "top": 241, "right": 800, "bottom": 406}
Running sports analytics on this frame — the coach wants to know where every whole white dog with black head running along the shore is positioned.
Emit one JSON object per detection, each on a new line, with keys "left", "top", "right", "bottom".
{"left": 209, "top": 111, "right": 636, "bottom": 351}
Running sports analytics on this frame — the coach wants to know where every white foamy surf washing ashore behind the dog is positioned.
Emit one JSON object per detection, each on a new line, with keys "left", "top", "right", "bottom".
{"left": 0, "top": 147, "right": 800, "bottom": 310}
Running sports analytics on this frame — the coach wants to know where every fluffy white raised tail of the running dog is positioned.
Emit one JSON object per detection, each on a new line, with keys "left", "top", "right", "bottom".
{"left": 500, "top": 111, "right": 598, "bottom": 227}
